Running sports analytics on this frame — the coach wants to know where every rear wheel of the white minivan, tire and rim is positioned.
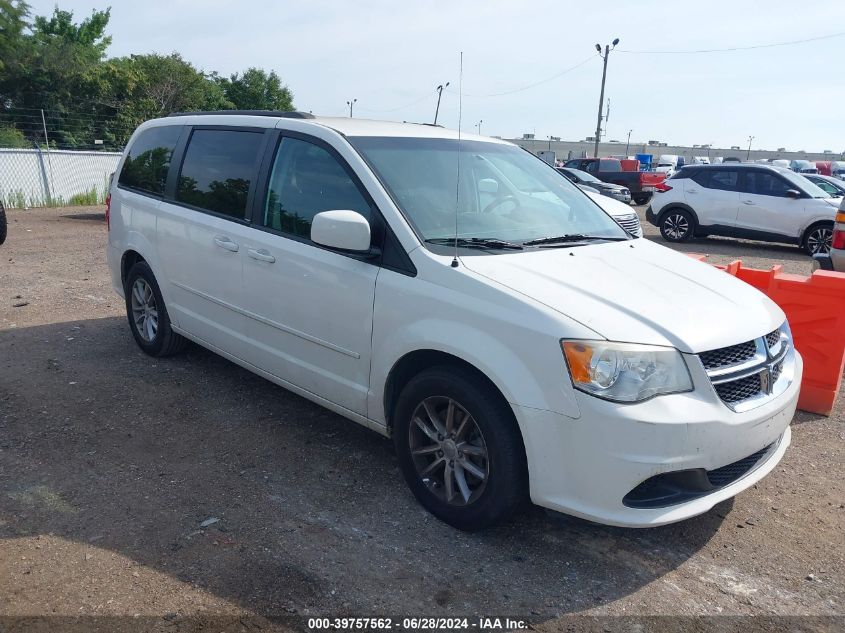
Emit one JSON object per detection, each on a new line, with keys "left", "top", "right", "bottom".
{"left": 124, "top": 262, "right": 187, "bottom": 357}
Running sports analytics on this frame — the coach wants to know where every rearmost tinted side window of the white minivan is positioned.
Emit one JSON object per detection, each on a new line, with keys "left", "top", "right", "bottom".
{"left": 117, "top": 125, "right": 182, "bottom": 196}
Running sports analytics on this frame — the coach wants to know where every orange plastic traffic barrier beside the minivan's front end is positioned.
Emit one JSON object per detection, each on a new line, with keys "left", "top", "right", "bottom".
{"left": 692, "top": 255, "right": 845, "bottom": 415}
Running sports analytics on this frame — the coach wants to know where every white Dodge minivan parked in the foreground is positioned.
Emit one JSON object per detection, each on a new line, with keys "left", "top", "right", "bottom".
{"left": 107, "top": 112, "right": 802, "bottom": 530}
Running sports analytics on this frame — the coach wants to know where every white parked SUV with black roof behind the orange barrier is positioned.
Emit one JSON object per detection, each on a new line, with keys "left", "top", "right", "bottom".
{"left": 646, "top": 164, "right": 840, "bottom": 254}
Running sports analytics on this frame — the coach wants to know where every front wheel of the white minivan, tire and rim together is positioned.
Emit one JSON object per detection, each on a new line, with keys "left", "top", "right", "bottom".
{"left": 393, "top": 367, "right": 528, "bottom": 531}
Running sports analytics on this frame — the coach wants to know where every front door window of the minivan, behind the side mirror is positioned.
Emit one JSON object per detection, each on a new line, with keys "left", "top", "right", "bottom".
{"left": 262, "top": 137, "right": 370, "bottom": 238}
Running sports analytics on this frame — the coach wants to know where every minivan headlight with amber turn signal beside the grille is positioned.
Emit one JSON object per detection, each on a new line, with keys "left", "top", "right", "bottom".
{"left": 560, "top": 341, "right": 692, "bottom": 402}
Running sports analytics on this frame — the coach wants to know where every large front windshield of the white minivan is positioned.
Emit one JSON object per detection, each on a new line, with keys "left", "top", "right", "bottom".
{"left": 349, "top": 136, "right": 628, "bottom": 247}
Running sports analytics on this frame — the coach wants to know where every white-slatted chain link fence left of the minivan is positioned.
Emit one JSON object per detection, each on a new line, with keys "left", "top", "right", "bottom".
{"left": 0, "top": 148, "right": 121, "bottom": 209}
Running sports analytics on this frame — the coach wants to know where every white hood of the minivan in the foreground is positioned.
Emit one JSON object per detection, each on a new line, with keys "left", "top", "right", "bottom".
{"left": 461, "top": 239, "right": 786, "bottom": 353}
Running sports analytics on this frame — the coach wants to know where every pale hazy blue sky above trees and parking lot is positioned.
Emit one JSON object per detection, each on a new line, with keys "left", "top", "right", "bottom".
{"left": 23, "top": 0, "right": 845, "bottom": 153}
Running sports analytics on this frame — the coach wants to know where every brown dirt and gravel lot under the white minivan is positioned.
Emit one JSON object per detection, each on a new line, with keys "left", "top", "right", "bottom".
{"left": 0, "top": 208, "right": 845, "bottom": 631}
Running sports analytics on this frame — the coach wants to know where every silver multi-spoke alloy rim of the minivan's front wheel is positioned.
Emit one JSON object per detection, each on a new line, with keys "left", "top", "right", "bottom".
{"left": 408, "top": 396, "right": 490, "bottom": 506}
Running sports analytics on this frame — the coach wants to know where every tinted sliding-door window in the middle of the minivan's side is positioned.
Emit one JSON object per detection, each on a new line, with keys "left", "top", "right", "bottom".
{"left": 176, "top": 129, "right": 264, "bottom": 220}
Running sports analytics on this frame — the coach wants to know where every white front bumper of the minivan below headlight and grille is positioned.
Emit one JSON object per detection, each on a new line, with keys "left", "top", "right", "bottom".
{"left": 514, "top": 354, "right": 803, "bottom": 527}
